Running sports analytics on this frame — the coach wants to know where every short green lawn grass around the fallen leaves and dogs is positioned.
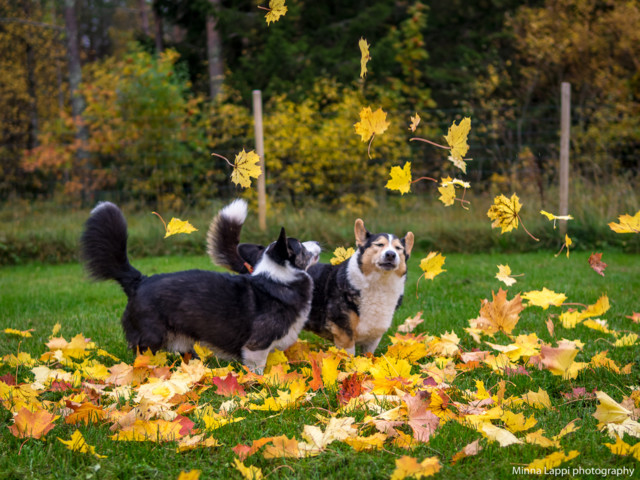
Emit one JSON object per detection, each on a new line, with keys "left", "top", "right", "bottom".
{"left": 0, "top": 251, "right": 640, "bottom": 479}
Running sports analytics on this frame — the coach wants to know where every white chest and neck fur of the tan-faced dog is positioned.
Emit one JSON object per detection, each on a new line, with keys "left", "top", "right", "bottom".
{"left": 347, "top": 251, "right": 406, "bottom": 352}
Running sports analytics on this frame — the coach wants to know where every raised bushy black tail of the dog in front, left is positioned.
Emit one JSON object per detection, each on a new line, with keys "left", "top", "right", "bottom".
{"left": 80, "top": 202, "right": 143, "bottom": 297}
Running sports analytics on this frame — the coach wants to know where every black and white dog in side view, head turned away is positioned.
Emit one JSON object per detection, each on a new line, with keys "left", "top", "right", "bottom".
{"left": 81, "top": 202, "right": 320, "bottom": 372}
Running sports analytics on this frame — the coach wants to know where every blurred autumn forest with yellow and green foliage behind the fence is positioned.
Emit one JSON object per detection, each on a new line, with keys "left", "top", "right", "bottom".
{"left": 0, "top": 0, "right": 640, "bottom": 208}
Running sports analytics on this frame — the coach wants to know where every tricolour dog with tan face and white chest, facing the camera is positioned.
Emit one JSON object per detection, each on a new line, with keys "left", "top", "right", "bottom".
{"left": 207, "top": 200, "right": 414, "bottom": 354}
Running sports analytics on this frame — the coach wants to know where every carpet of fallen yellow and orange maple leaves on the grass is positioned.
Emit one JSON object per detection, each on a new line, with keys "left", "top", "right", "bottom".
{"left": 0, "top": 289, "right": 640, "bottom": 479}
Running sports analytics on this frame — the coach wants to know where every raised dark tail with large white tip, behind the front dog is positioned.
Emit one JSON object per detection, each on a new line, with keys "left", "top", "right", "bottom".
{"left": 207, "top": 199, "right": 249, "bottom": 273}
